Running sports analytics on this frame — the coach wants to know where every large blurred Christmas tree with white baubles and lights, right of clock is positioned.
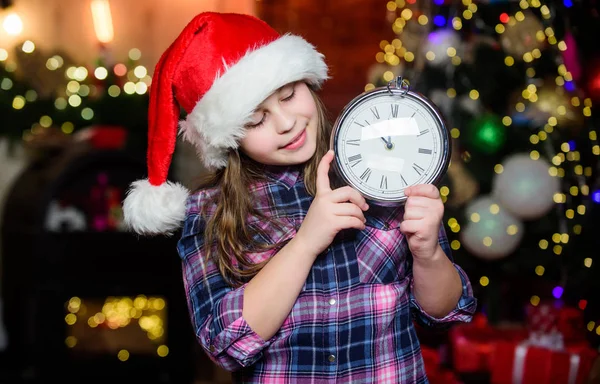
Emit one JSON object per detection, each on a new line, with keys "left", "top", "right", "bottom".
{"left": 365, "top": 0, "right": 600, "bottom": 345}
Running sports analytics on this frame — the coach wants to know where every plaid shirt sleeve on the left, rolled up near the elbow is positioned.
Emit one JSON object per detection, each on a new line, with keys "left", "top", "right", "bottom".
{"left": 178, "top": 210, "right": 277, "bottom": 371}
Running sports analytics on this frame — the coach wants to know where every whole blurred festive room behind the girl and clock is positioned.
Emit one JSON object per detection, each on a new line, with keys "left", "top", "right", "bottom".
{"left": 0, "top": 0, "right": 600, "bottom": 383}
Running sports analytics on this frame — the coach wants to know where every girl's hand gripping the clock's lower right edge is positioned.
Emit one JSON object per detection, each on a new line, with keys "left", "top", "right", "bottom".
{"left": 400, "top": 184, "right": 444, "bottom": 260}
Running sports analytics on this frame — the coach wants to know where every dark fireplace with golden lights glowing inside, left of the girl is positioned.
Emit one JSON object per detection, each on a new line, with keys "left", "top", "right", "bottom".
{"left": 2, "top": 146, "right": 197, "bottom": 383}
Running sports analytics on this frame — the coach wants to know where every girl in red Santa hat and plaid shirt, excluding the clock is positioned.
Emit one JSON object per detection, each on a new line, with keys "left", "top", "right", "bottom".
{"left": 124, "top": 13, "right": 476, "bottom": 383}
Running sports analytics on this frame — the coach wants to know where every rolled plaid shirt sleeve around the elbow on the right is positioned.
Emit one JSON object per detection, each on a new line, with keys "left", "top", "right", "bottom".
{"left": 407, "top": 225, "right": 477, "bottom": 328}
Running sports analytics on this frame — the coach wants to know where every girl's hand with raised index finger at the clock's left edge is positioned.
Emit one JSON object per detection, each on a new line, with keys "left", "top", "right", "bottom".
{"left": 295, "top": 150, "right": 369, "bottom": 256}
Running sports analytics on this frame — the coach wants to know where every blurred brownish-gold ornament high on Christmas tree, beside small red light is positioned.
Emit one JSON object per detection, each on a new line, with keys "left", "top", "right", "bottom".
{"left": 500, "top": 11, "right": 544, "bottom": 59}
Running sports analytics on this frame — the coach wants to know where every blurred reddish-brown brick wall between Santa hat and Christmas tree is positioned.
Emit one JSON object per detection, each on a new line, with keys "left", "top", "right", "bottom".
{"left": 256, "top": 0, "right": 394, "bottom": 116}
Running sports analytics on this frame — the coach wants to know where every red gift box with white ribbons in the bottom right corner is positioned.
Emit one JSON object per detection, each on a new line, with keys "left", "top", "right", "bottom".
{"left": 491, "top": 341, "right": 597, "bottom": 384}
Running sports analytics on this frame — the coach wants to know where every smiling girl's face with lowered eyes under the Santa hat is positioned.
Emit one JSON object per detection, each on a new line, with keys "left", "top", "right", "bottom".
{"left": 240, "top": 81, "right": 319, "bottom": 165}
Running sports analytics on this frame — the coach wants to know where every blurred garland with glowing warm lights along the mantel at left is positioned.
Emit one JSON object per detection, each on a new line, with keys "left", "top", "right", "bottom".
{"left": 0, "top": 40, "right": 151, "bottom": 153}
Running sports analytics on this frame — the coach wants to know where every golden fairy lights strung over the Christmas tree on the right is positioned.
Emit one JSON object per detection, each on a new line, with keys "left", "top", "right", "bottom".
{"left": 376, "top": 0, "right": 600, "bottom": 335}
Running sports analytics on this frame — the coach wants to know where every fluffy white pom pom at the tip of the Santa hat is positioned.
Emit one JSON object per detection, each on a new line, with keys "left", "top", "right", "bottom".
{"left": 123, "top": 179, "right": 189, "bottom": 235}
